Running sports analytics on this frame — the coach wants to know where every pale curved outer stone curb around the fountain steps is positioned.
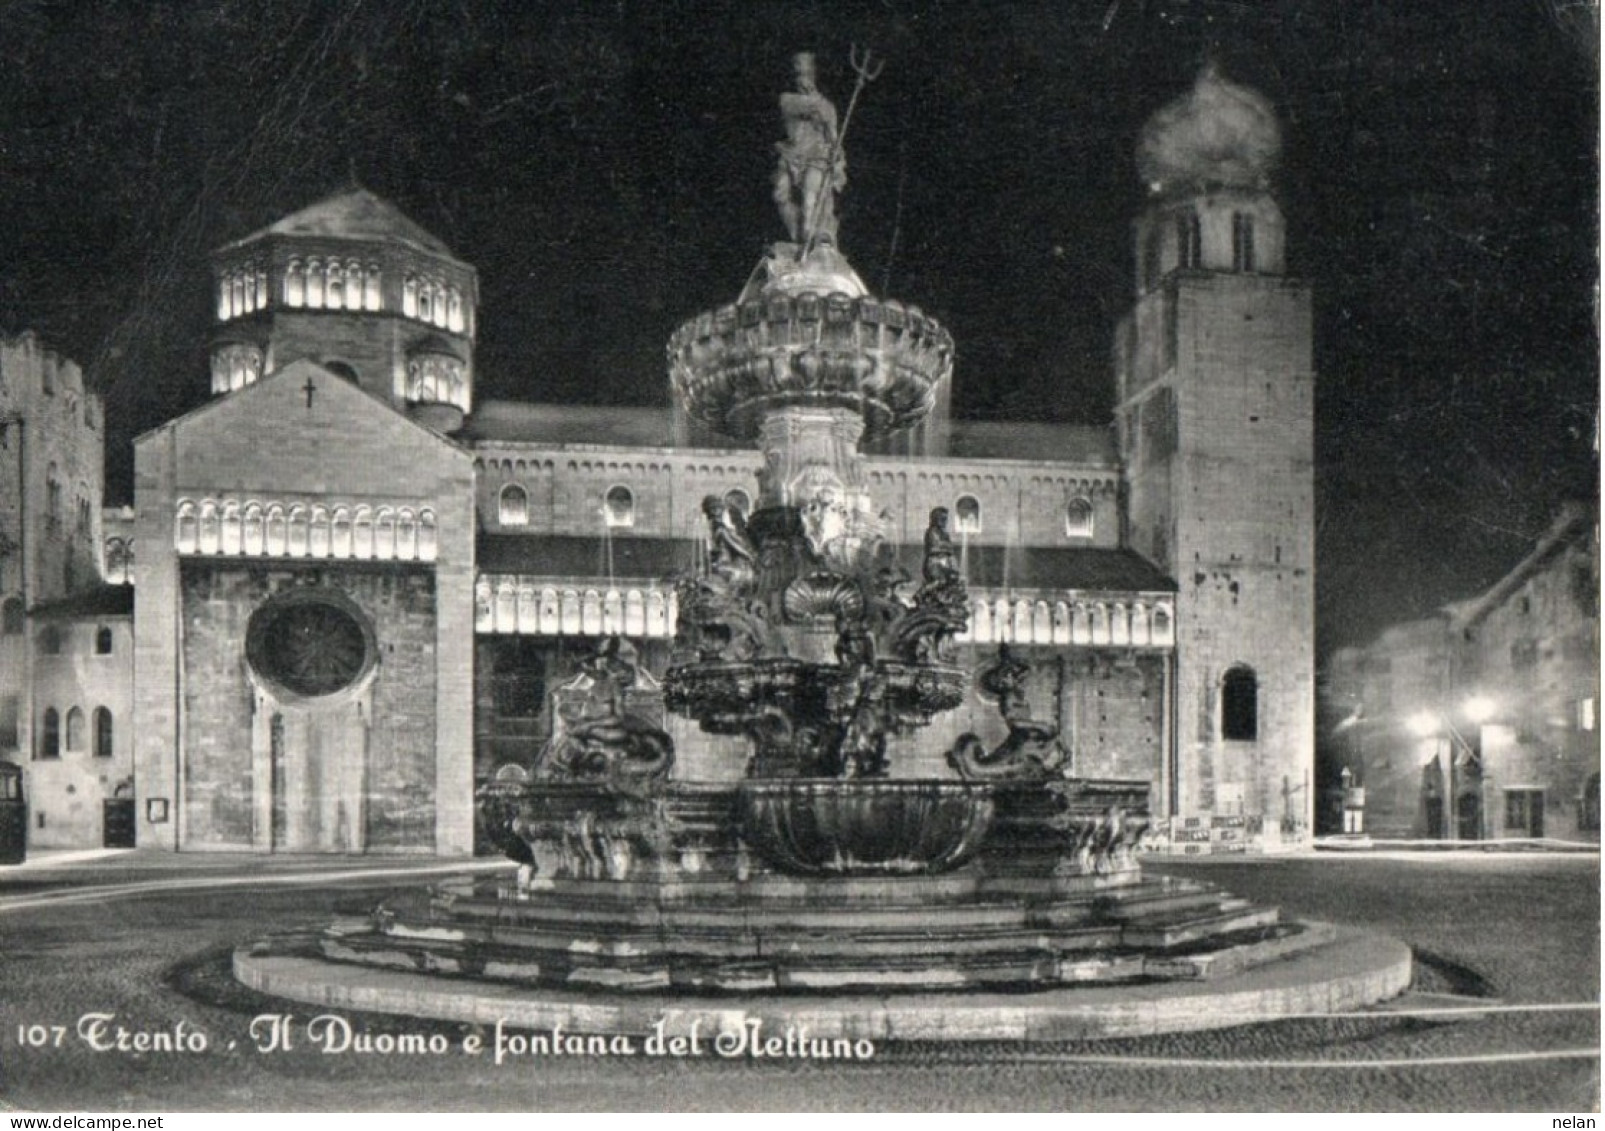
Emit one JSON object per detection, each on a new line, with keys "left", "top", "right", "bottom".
{"left": 234, "top": 927, "right": 1411, "bottom": 1041}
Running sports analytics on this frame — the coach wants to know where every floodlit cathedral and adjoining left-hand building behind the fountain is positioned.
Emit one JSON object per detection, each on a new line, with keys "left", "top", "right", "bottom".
{"left": 0, "top": 72, "right": 1314, "bottom": 855}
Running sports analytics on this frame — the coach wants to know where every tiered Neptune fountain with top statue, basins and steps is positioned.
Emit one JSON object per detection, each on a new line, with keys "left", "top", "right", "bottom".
{"left": 237, "top": 56, "right": 1408, "bottom": 1032}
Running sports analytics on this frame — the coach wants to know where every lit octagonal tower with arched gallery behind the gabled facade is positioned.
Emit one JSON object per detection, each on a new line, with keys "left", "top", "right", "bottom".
{"left": 212, "top": 189, "right": 478, "bottom": 432}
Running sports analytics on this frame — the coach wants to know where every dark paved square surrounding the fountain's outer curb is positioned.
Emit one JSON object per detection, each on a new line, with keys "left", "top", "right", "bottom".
{"left": 0, "top": 853, "right": 1600, "bottom": 1113}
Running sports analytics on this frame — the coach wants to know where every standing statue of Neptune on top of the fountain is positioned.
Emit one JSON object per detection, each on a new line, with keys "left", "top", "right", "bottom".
{"left": 775, "top": 51, "right": 847, "bottom": 247}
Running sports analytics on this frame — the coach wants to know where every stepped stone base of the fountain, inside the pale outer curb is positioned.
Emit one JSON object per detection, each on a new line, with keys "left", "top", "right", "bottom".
{"left": 306, "top": 874, "right": 1300, "bottom": 990}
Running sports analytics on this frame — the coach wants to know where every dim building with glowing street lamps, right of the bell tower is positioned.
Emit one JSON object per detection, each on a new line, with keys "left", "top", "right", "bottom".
{"left": 1323, "top": 502, "right": 1600, "bottom": 841}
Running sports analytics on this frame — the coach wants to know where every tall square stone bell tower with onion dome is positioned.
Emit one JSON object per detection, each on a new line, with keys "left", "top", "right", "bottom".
{"left": 1115, "top": 66, "right": 1314, "bottom": 842}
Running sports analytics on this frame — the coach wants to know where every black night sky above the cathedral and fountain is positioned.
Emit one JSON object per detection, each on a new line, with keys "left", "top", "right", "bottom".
{"left": 0, "top": 0, "right": 1599, "bottom": 651}
